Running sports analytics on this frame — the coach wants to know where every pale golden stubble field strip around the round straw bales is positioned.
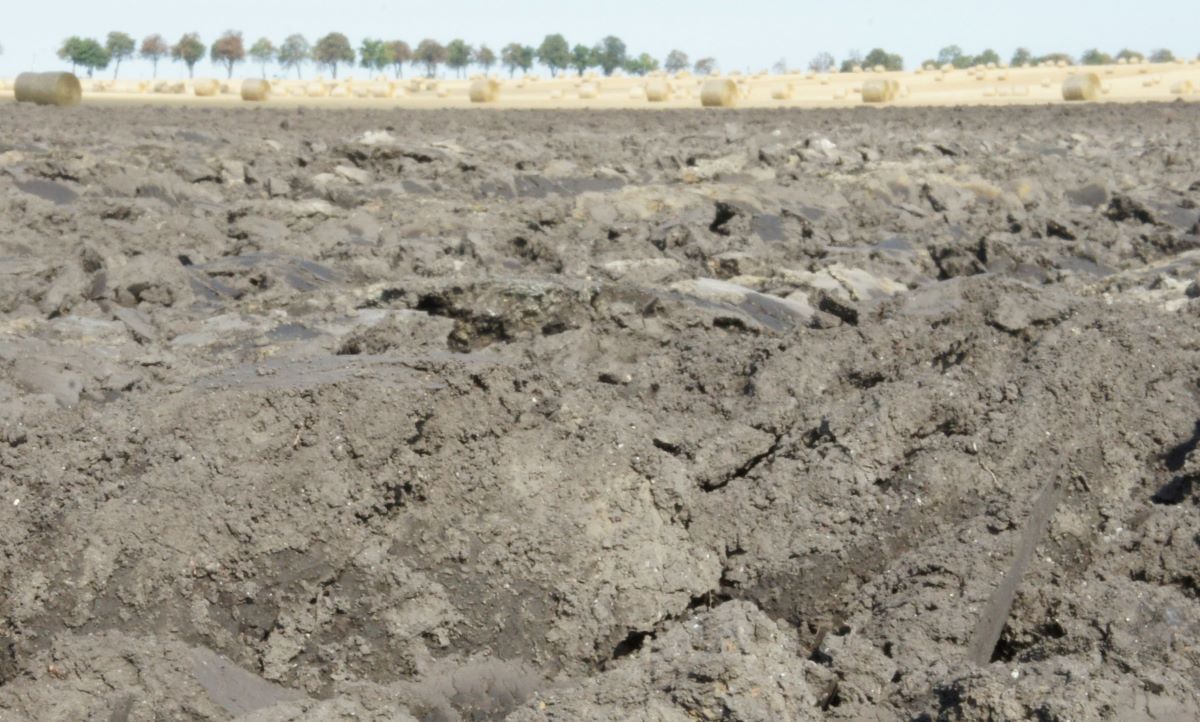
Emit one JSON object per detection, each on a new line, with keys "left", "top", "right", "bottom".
{"left": 0, "top": 62, "right": 1200, "bottom": 109}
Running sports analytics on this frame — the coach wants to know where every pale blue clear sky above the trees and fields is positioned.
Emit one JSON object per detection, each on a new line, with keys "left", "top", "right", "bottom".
{"left": 0, "top": 0, "right": 1200, "bottom": 77}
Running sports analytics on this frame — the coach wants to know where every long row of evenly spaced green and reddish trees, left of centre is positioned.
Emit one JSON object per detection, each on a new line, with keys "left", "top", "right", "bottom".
{"left": 58, "top": 30, "right": 716, "bottom": 78}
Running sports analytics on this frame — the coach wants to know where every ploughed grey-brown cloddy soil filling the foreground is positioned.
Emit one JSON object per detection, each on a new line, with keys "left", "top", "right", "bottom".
{"left": 0, "top": 104, "right": 1200, "bottom": 722}
